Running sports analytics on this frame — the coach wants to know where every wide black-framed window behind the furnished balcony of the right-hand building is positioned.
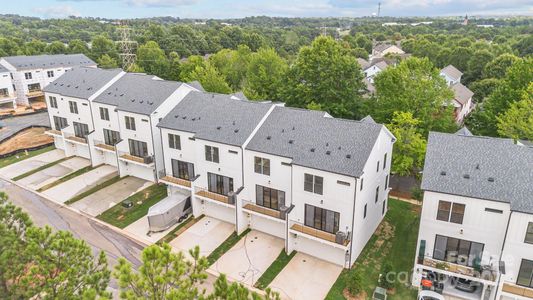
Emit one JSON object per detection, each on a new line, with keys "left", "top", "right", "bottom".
{"left": 433, "top": 235, "right": 485, "bottom": 267}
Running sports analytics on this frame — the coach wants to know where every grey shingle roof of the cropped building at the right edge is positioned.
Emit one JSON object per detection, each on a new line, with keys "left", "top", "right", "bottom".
{"left": 422, "top": 132, "right": 533, "bottom": 213}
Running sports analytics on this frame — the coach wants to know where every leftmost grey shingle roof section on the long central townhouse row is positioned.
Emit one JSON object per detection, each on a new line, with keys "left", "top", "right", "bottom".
{"left": 44, "top": 68, "right": 122, "bottom": 99}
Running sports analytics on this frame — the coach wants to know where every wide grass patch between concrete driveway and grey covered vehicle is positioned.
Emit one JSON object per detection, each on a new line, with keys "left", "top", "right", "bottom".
{"left": 97, "top": 184, "right": 167, "bottom": 228}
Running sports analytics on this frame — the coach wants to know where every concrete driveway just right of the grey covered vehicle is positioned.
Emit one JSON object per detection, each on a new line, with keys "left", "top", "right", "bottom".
{"left": 170, "top": 216, "right": 235, "bottom": 256}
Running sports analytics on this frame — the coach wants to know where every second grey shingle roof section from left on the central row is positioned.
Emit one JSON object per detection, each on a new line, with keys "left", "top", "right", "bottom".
{"left": 94, "top": 73, "right": 182, "bottom": 115}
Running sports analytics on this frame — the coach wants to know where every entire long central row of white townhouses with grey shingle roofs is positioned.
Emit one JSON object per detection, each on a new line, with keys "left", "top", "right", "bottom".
{"left": 45, "top": 68, "right": 395, "bottom": 267}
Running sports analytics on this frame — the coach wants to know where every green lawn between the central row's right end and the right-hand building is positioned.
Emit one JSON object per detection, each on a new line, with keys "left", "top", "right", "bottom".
{"left": 326, "top": 198, "right": 420, "bottom": 300}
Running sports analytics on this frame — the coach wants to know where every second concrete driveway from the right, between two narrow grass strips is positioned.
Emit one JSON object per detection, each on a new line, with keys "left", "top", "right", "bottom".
{"left": 210, "top": 230, "right": 284, "bottom": 286}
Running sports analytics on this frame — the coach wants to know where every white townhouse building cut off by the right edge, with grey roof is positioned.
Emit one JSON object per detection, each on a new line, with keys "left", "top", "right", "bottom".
{"left": 412, "top": 129, "right": 533, "bottom": 300}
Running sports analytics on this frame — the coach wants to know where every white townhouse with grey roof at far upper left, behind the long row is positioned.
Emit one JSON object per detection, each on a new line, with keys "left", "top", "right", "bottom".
{"left": 0, "top": 54, "right": 96, "bottom": 106}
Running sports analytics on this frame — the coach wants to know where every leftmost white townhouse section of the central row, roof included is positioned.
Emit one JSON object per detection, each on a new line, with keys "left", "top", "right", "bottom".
{"left": 44, "top": 67, "right": 124, "bottom": 159}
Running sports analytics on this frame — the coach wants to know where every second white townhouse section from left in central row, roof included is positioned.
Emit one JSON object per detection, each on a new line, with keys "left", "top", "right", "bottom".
{"left": 89, "top": 73, "right": 196, "bottom": 182}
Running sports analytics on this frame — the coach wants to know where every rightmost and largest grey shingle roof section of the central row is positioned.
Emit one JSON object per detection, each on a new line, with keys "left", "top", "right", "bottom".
{"left": 246, "top": 107, "right": 383, "bottom": 177}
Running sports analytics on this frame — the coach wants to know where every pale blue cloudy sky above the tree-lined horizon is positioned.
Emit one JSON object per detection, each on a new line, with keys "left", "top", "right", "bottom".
{"left": 0, "top": 0, "right": 533, "bottom": 19}
